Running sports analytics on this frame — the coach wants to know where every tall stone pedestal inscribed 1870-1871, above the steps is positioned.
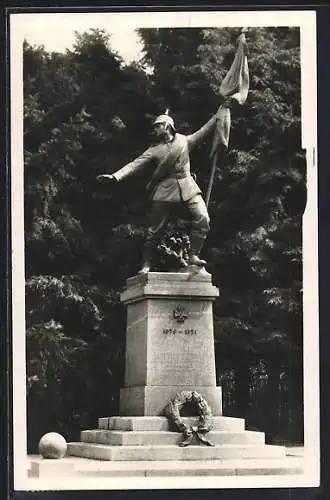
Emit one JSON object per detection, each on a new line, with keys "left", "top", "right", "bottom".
{"left": 120, "top": 272, "right": 222, "bottom": 416}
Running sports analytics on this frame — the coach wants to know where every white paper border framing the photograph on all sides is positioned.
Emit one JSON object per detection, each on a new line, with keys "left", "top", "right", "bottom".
{"left": 10, "top": 10, "right": 320, "bottom": 491}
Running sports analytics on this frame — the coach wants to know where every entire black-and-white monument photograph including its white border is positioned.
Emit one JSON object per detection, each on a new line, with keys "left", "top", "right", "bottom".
{"left": 10, "top": 9, "right": 320, "bottom": 491}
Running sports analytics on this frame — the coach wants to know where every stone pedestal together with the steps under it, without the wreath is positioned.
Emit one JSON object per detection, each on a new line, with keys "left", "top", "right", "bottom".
{"left": 68, "top": 270, "right": 304, "bottom": 475}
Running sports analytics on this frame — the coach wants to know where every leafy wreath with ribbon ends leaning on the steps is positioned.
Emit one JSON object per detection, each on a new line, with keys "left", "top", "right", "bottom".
{"left": 165, "top": 391, "right": 214, "bottom": 446}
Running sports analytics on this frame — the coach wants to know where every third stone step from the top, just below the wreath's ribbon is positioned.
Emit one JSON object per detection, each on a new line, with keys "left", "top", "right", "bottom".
{"left": 67, "top": 442, "right": 285, "bottom": 461}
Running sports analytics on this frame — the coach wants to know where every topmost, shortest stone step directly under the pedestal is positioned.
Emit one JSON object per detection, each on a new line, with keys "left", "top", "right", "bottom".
{"left": 98, "top": 416, "right": 245, "bottom": 431}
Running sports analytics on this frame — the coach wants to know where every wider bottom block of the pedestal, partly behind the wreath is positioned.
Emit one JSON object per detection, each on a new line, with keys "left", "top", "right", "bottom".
{"left": 120, "top": 385, "right": 222, "bottom": 417}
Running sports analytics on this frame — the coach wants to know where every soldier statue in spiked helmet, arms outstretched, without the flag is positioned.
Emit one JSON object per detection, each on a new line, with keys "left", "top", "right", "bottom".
{"left": 97, "top": 105, "right": 230, "bottom": 273}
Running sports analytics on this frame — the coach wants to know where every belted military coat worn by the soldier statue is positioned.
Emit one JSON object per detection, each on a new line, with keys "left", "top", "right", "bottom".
{"left": 113, "top": 115, "right": 216, "bottom": 202}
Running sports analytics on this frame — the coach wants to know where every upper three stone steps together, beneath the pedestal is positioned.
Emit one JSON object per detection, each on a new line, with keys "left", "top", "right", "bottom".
{"left": 68, "top": 416, "right": 292, "bottom": 468}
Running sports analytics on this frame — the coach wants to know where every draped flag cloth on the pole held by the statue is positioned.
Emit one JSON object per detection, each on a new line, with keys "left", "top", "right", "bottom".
{"left": 210, "top": 30, "right": 250, "bottom": 158}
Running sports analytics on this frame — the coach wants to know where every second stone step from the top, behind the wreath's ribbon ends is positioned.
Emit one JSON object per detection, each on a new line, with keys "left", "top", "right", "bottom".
{"left": 80, "top": 429, "right": 265, "bottom": 446}
